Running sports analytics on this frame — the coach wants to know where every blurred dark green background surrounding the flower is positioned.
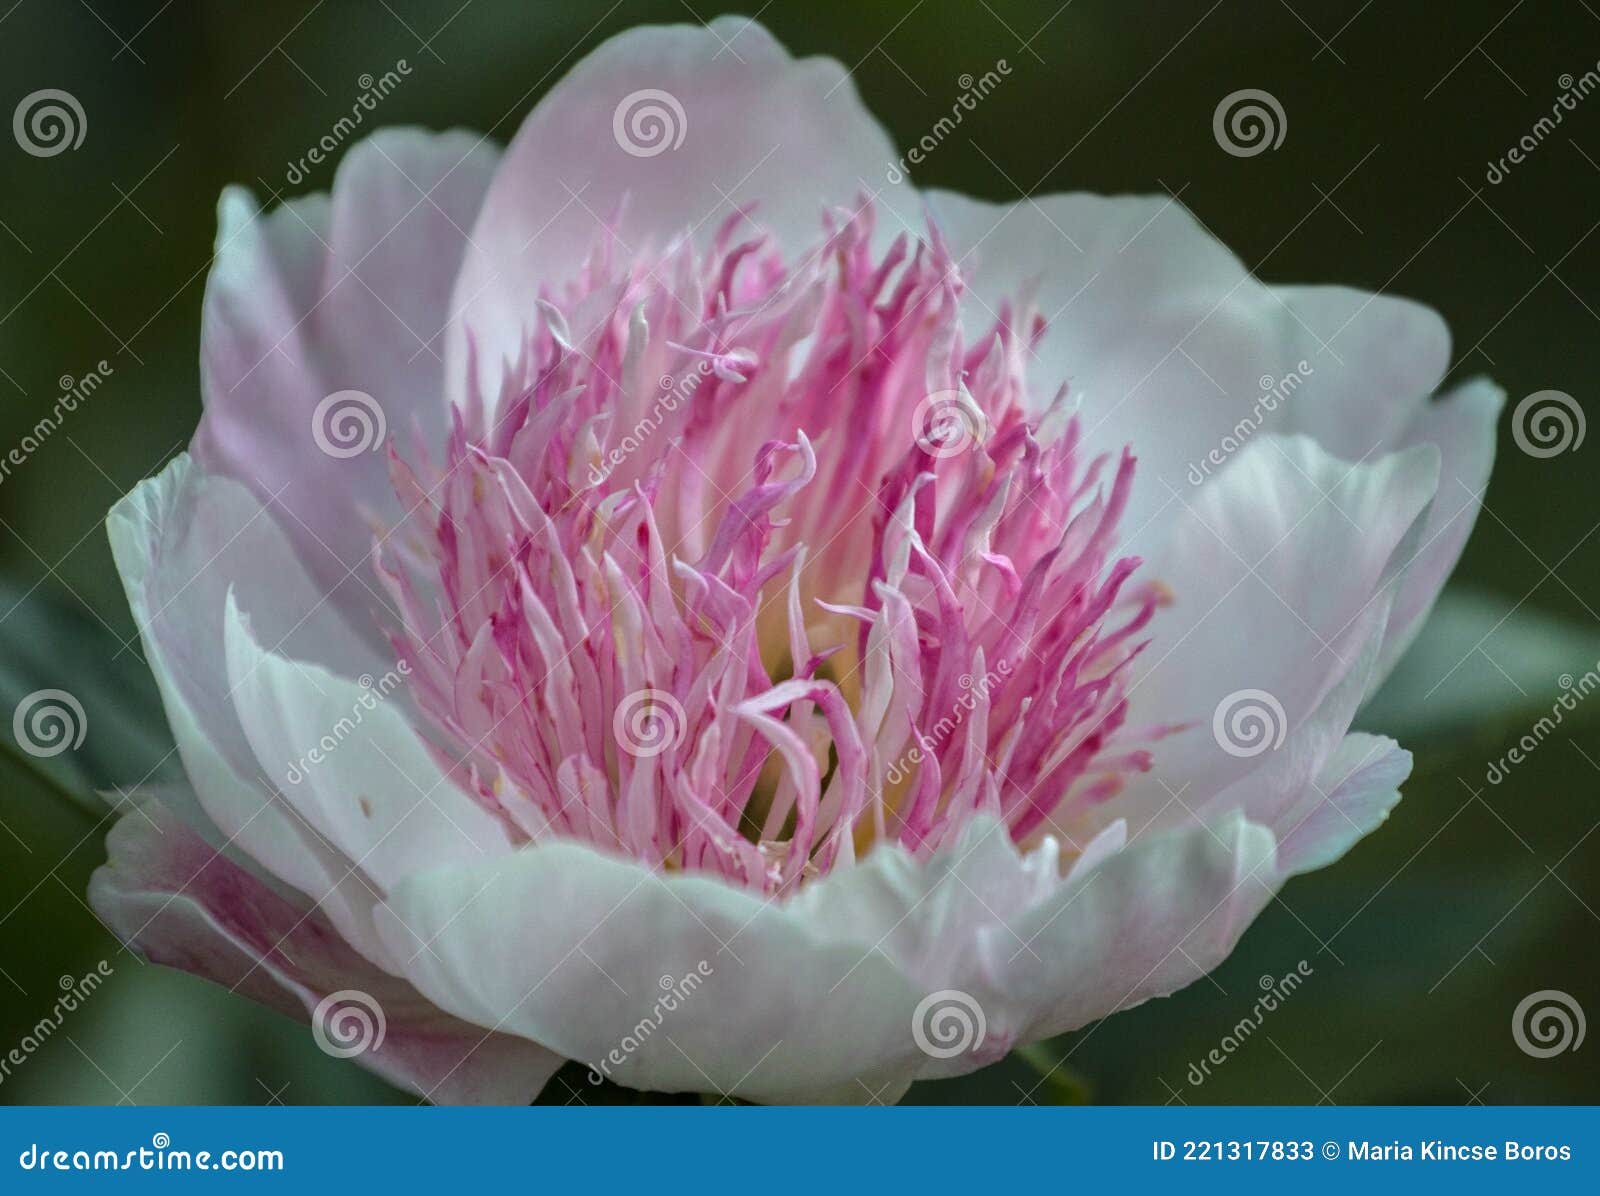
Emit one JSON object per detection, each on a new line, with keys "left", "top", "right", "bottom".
{"left": 0, "top": 0, "right": 1600, "bottom": 1103}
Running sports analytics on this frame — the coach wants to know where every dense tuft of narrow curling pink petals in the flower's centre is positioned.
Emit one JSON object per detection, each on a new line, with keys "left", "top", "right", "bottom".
{"left": 379, "top": 208, "right": 1158, "bottom": 892}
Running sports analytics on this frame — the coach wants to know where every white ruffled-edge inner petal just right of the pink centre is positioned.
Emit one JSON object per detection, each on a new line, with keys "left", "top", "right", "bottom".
{"left": 1118, "top": 437, "right": 1438, "bottom": 812}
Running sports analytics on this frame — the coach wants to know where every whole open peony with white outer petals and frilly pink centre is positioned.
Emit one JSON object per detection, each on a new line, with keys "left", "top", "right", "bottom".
{"left": 91, "top": 19, "right": 1501, "bottom": 1102}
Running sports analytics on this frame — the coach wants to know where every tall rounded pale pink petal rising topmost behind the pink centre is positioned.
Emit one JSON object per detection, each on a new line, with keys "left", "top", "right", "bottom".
{"left": 446, "top": 16, "right": 922, "bottom": 412}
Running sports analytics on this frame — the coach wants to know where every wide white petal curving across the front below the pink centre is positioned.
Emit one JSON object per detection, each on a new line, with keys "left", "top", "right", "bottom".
{"left": 363, "top": 802, "right": 1324, "bottom": 1102}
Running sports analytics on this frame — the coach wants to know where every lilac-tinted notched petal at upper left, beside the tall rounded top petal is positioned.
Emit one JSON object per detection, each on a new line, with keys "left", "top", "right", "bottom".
{"left": 194, "top": 128, "right": 498, "bottom": 617}
